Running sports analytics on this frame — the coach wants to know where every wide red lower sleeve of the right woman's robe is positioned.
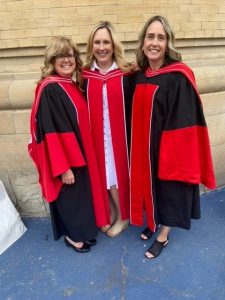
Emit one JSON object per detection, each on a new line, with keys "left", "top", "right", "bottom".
{"left": 158, "top": 126, "right": 216, "bottom": 189}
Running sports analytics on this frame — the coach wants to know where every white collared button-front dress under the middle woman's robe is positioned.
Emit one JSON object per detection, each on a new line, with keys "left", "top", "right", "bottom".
{"left": 91, "top": 61, "right": 118, "bottom": 189}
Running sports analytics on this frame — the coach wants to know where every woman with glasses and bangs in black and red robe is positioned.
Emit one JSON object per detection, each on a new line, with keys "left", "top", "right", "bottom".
{"left": 29, "top": 37, "right": 107, "bottom": 253}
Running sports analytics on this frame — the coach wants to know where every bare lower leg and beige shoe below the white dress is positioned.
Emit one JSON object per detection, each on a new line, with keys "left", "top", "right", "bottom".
{"left": 107, "top": 186, "right": 129, "bottom": 237}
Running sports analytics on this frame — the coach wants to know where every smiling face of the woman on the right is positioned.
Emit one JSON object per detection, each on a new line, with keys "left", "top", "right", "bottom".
{"left": 142, "top": 21, "right": 167, "bottom": 70}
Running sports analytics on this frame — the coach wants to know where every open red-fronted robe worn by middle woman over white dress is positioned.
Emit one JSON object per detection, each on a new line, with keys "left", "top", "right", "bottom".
{"left": 82, "top": 69, "right": 132, "bottom": 224}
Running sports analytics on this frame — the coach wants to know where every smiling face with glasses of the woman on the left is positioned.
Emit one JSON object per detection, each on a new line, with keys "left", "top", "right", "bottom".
{"left": 54, "top": 49, "right": 76, "bottom": 78}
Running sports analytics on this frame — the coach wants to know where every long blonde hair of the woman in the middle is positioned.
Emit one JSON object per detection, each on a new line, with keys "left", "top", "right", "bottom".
{"left": 84, "top": 21, "right": 132, "bottom": 71}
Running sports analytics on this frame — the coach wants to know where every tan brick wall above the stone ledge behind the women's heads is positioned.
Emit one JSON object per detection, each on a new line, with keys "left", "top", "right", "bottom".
{"left": 0, "top": 0, "right": 225, "bottom": 49}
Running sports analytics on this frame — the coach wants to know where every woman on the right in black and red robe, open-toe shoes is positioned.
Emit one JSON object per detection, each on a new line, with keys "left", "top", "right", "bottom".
{"left": 131, "top": 16, "right": 215, "bottom": 258}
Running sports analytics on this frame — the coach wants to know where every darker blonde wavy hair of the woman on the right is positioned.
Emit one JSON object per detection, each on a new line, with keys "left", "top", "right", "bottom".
{"left": 136, "top": 15, "right": 181, "bottom": 72}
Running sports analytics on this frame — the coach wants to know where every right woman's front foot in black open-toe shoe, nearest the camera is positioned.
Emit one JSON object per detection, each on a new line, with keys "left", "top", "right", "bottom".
{"left": 145, "top": 225, "right": 170, "bottom": 259}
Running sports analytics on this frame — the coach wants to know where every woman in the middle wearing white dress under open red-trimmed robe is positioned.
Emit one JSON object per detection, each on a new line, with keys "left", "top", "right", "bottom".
{"left": 82, "top": 21, "right": 133, "bottom": 237}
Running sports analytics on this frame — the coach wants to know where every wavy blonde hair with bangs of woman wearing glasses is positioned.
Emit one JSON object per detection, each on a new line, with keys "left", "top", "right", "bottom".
{"left": 39, "top": 36, "right": 83, "bottom": 89}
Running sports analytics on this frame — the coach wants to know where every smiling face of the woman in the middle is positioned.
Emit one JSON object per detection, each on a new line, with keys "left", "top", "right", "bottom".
{"left": 93, "top": 28, "right": 113, "bottom": 69}
